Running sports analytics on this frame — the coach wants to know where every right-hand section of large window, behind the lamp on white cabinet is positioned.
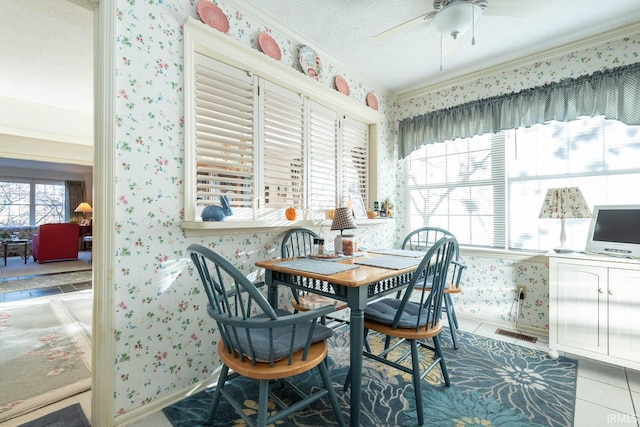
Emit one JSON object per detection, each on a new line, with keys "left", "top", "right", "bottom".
{"left": 507, "top": 117, "right": 640, "bottom": 250}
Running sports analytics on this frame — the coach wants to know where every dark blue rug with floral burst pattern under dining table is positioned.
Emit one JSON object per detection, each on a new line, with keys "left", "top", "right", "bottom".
{"left": 164, "top": 328, "right": 577, "bottom": 427}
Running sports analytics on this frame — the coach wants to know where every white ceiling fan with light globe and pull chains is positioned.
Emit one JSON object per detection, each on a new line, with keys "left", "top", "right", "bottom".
{"left": 373, "top": 0, "right": 551, "bottom": 40}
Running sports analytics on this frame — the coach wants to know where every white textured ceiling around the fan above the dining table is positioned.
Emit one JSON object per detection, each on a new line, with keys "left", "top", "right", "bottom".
{"left": 242, "top": 0, "right": 640, "bottom": 94}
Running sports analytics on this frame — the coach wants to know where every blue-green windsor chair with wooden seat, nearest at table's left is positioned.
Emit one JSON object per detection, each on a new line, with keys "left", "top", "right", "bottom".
{"left": 188, "top": 244, "right": 345, "bottom": 427}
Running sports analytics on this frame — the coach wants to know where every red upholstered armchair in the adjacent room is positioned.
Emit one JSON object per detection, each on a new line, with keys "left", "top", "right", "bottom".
{"left": 31, "top": 223, "right": 79, "bottom": 264}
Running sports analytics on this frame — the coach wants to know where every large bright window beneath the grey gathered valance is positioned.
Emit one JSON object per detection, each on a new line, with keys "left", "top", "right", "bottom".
{"left": 405, "top": 117, "right": 640, "bottom": 251}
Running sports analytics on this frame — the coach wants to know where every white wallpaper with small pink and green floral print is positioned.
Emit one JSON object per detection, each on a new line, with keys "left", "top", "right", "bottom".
{"left": 113, "top": 0, "right": 637, "bottom": 415}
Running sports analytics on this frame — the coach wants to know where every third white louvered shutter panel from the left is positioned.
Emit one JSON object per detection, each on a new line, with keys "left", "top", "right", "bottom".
{"left": 309, "top": 103, "right": 338, "bottom": 211}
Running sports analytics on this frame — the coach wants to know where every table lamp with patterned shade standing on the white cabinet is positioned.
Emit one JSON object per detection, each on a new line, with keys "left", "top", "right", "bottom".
{"left": 539, "top": 187, "right": 591, "bottom": 253}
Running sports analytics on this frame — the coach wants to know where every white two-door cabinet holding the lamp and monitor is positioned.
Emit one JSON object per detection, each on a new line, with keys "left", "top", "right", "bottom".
{"left": 549, "top": 253, "right": 640, "bottom": 370}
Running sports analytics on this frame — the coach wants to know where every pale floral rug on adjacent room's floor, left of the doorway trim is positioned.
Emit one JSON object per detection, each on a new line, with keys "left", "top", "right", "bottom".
{"left": 0, "top": 290, "right": 93, "bottom": 422}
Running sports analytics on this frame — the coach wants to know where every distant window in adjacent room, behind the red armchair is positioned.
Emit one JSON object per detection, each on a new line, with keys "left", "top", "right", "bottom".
{"left": 0, "top": 181, "right": 65, "bottom": 226}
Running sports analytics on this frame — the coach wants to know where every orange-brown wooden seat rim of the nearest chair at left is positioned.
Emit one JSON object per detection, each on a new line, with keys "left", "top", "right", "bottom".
{"left": 218, "top": 341, "right": 328, "bottom": 380}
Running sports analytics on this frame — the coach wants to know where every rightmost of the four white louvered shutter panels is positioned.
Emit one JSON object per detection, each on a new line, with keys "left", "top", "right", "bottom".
{"left": 341, "top": 119, "right": 369, "bottom": 207}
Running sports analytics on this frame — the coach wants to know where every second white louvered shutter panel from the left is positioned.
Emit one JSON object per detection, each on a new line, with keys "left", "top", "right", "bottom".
{"left": 263, "top": 82, "right": 305, "bottom": 210}
